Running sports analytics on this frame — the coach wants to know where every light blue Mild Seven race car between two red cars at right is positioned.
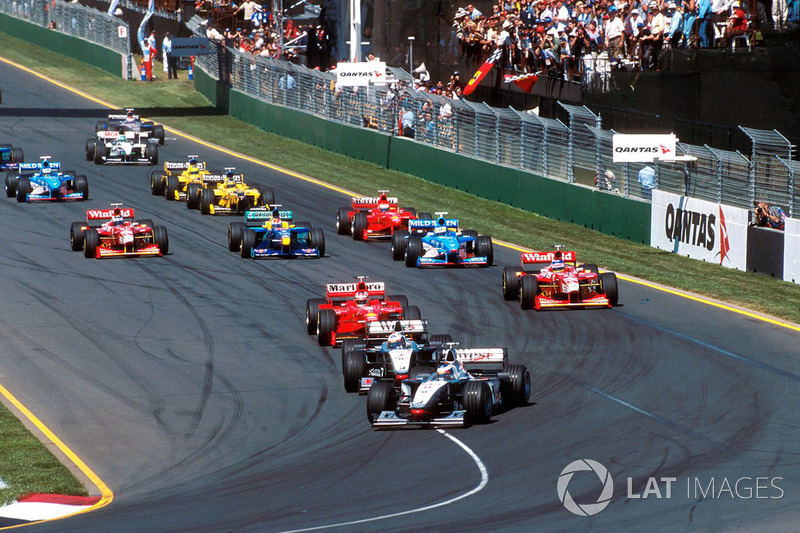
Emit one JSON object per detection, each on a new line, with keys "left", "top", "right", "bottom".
{"left": 392, "top": 213, "right": 494, "bottom": 267}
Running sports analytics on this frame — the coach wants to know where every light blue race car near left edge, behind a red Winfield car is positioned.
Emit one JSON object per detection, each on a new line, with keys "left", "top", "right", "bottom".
{"left": 6, "top": 156, "right": 89, "bottom": 202}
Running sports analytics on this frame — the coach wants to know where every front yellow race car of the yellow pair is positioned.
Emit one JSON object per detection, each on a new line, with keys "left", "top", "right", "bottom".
{"left": 200, "top": 168, "right": 275, "bottom": 215}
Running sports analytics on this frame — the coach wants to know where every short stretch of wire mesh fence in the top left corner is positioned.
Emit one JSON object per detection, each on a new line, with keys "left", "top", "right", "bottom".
{"left": 0, "top": 0, "right": 131, "bottom": 56}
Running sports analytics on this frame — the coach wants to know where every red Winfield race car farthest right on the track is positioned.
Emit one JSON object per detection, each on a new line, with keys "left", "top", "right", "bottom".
{"left": 503, "top": 245, "right": 619, "bottom": 309}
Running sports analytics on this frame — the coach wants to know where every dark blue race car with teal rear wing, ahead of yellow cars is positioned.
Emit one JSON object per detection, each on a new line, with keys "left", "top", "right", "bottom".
{"left": 228, "top": 206, "right": 325, "bottom": 259}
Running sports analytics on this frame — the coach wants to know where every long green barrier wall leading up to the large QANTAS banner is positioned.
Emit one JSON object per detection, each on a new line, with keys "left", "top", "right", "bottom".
{"left": 195, "top": 69, "right": 650, "bottom": 244}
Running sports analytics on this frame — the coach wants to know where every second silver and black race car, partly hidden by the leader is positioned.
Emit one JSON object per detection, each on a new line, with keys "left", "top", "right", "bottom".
{"left": 342, "top": 320, "right": 452, "bottom": 394}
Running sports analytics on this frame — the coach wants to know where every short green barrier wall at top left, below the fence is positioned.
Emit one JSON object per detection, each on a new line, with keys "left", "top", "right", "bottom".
{"left": 0, "top": 13, "right": 123, "bottom": 76}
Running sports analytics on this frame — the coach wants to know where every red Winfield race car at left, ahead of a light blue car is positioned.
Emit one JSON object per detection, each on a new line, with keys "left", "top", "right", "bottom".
{"left": 69, "top": 204, "right": 169, "bottom": 259}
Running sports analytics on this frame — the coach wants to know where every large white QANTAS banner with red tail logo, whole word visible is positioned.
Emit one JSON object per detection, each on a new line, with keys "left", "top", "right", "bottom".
{"left": 650, "top": 190, "right": 748, "bottom": 270}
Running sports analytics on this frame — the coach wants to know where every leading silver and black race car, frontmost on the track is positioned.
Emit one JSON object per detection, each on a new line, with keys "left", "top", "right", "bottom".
{"left": 367, "top": 348, "right": 531, "bottom": 427}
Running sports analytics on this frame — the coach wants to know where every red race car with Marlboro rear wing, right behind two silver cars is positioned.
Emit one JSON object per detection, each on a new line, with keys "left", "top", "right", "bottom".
{"left": 306, "top": 276, "right": 421, "bottom": 349}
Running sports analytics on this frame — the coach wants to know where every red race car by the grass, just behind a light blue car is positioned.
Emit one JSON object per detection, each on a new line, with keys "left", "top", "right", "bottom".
{"left": 336, "top": 191, "right": 431, "bottom": 241}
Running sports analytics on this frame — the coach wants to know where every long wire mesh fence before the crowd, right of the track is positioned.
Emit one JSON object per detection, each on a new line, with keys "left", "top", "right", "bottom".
{"left": 189, "top": 14, "right": 800, "bottom": 216}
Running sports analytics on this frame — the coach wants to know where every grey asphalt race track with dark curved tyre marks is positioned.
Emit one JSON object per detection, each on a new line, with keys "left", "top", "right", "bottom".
{"left": 0, "top": 60, "right": 800, "bottom": 532}
